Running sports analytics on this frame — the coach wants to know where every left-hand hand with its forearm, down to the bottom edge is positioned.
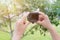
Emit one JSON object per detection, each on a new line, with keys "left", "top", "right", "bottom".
{"left": 12, "top": 12, "right": 29, "bottom": 40}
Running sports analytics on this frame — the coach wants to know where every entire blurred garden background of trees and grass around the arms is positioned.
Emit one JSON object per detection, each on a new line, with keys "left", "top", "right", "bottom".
{"left": 0, "top": 0, "right": 60, "bottom": 40}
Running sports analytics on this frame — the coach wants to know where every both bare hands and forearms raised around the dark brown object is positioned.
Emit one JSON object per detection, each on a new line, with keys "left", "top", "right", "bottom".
{"left": 12, "top": 12, "right": 60, "bottom": 40}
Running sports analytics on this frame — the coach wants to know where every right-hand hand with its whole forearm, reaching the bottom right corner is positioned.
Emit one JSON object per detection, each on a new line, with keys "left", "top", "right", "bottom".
{"left": 37, "top": 12, "right": 60, "bottom": 40}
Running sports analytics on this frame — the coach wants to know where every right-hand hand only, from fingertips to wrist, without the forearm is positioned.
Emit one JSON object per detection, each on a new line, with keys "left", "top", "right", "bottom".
{"left": 37, "top": 12, "right": 52, "bottom": 29}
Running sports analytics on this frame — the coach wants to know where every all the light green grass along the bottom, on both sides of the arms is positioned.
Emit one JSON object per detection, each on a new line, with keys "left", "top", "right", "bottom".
{"left": 0, "top": 24, "right": 60, "bottom": 40}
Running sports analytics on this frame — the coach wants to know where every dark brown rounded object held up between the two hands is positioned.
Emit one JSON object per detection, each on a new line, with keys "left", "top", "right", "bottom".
{"left": 27, "top": 12, "right": 39, "bottom": 23}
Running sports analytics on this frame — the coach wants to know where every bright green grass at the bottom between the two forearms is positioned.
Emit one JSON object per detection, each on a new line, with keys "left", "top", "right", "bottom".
{"left": 22, "top": 31, "right": 52, "bottom": 40}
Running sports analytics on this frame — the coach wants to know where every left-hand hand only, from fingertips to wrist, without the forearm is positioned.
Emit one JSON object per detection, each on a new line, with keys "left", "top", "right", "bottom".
{"left": 14, "top": 12, "right": 29, "bottom": 34}
